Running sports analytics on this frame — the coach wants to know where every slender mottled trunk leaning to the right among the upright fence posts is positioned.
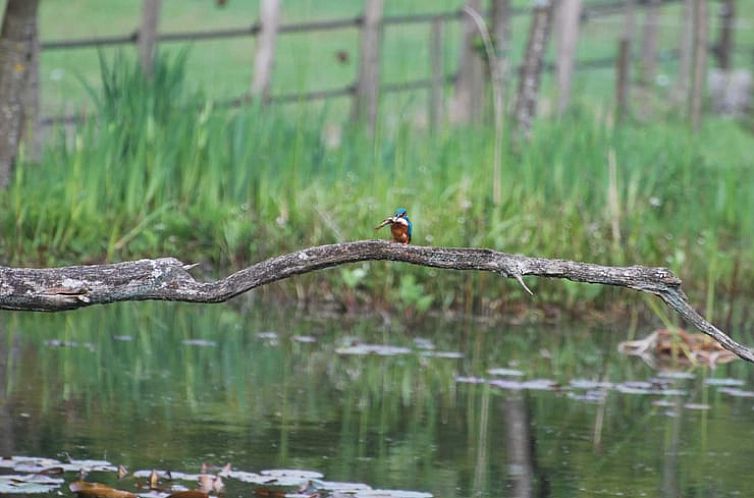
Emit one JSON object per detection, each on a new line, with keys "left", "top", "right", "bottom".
{"left": 514, "top": 3, "right": 553, "bottom": 138}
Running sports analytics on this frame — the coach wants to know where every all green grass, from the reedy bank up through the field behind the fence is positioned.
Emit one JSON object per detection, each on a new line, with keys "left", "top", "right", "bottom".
{"left": 0, "top": 0, "right": 754, "bottom": 320}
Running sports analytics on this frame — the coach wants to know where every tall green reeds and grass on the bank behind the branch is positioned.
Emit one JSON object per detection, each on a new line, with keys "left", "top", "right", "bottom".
{"left": 0, "top": 58, "right": 754, "bottom": 320}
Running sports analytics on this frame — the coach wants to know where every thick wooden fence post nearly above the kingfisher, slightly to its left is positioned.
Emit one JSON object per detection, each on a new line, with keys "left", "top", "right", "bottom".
{"left": 351, "top": 0, "right": 383, "bottom": 132}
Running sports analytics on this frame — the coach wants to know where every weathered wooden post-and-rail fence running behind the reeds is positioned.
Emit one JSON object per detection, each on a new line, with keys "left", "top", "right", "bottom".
{"left": 41, "top": 0, "right": 744, "bottom": 133}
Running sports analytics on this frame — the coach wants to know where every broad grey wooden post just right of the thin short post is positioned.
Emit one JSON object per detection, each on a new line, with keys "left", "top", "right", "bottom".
{"left": 450, "top": 0, "right": 484, "bottom": 123}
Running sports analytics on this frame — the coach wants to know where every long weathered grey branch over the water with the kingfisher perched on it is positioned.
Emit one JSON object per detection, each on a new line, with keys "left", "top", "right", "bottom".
{"left": 0, "top": 240, "right": 754, "bottom": 363}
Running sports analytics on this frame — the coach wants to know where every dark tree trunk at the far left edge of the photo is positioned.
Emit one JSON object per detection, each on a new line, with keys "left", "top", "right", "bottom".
{"left": 0, "top": 0, "right": 38, "bottom": 189}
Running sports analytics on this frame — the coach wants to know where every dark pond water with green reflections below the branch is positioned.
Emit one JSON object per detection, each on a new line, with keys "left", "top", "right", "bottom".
{"left": 0, "top": 303, "right": 754, "bottom": 497}
